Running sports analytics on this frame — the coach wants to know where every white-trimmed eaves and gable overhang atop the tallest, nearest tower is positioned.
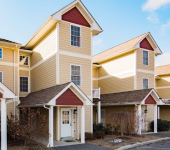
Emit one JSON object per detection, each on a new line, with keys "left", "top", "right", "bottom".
{"left": 25, "top": 0, "right": 103, "bottom": 49}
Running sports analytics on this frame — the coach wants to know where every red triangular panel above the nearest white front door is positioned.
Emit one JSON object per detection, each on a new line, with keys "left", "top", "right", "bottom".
{"left": 56, "top": 89, "right": 83, "bottom": 106}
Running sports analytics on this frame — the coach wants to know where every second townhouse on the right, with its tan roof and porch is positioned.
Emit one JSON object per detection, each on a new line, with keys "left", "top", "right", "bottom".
{"left": 93, "top": 32, "right": 163, "bottom": 133}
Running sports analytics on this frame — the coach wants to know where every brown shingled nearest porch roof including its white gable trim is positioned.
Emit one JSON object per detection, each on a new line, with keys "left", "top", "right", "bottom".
{"left": 18, "top": 82, "right": 92, "bottom": 107}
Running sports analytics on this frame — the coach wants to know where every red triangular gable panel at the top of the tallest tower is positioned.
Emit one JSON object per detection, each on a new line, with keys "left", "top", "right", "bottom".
{"left": 62, "top": 7, "right": 90, "bottom": 27}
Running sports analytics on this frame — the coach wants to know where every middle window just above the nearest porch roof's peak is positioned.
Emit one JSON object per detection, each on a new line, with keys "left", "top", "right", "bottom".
{"left": 71, "top": 65, "right": 81, "bottom": 86}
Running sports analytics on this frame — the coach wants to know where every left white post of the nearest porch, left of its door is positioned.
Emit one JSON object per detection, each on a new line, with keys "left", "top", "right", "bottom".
{"left": 49, "top": 106, "right": 53, "bottom": 147}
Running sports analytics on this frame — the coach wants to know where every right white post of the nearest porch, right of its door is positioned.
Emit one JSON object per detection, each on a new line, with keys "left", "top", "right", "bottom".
{"left": 81, "top": 106, "right": 85, "bottom": 143}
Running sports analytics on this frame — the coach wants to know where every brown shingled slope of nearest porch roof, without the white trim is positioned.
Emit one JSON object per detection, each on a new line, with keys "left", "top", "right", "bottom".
{"left": 18, "top": 82, "right": 71, "bottom": 107}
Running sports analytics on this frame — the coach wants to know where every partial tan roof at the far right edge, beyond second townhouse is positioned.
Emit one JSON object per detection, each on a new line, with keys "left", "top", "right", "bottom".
{"left": 155, "top": 65, "right": 170, "bottom": 75}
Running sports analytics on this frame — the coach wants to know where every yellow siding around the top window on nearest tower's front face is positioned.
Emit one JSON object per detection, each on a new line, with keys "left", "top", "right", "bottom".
{"left": 59, "top": 21, "right": 91, "bottom": 56}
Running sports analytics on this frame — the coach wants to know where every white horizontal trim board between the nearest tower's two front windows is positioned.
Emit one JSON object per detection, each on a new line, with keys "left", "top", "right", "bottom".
{"left": 59, "top": 50, "right": 92, "bottom": 59}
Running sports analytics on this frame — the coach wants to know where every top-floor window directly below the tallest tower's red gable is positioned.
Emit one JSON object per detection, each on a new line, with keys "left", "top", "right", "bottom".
{"left": 71, "top": 25, "right": 80, "bottom": 47}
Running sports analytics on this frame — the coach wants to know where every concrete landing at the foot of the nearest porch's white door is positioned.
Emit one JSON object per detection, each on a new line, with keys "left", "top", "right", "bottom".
{"left": 34, "top": 137, "right": 82, "bottom": 147}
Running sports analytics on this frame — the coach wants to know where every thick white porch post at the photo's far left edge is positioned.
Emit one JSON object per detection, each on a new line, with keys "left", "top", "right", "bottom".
{"left": 1, "top": 99, "right": 7, "bottom": 150}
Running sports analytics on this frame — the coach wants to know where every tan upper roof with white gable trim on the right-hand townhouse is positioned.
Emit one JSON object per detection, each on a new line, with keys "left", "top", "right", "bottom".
{"left": 93, "top": 32, "right": 162, "bottom": 63}
